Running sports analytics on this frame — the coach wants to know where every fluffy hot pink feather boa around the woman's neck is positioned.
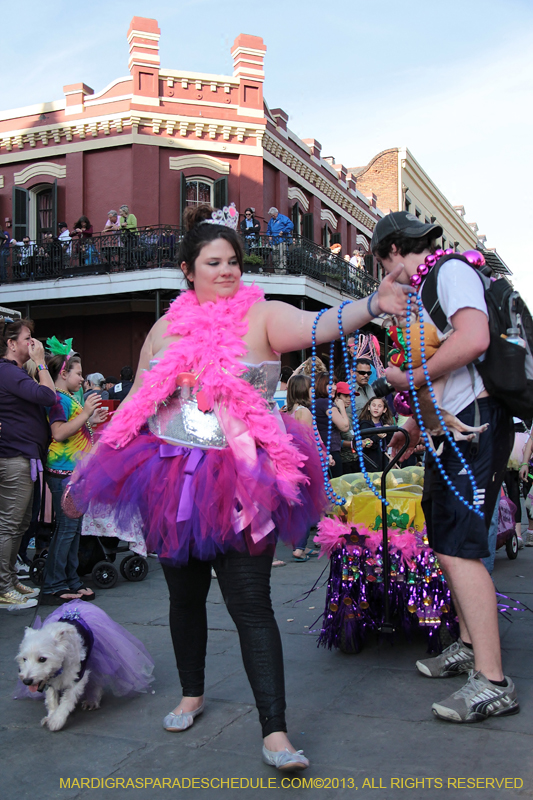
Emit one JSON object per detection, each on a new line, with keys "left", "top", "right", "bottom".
{"left": 102, "top": 286, "right": 308, "bottom": 501}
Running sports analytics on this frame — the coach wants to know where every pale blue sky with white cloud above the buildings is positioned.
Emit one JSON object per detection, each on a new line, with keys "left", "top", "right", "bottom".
{"left": 4, "top": 0, "right": 533, "bottom": 300}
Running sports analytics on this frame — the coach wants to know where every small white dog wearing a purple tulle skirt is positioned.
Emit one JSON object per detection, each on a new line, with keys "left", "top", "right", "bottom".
{"left": 15, "top": 600, "right": 154, "bottom": 731}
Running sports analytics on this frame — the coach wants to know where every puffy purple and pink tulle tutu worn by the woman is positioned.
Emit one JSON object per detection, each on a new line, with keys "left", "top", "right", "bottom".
{"left": 70, "top": 415, "right": 326, "bottom": 566}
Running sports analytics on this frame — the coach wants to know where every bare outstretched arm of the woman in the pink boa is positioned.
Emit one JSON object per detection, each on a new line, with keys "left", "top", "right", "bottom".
{"left": 266, "top": 265, "right": 410, "bottom": 353}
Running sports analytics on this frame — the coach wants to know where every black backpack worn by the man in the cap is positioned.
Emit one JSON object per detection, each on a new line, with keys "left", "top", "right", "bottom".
{"left": 421, "top": 253, "right": 533, "bottom": 419}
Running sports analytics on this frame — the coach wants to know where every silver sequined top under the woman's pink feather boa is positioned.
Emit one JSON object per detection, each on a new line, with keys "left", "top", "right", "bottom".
{"left": 143, "top": 360, "right": 281, "bottom": 450}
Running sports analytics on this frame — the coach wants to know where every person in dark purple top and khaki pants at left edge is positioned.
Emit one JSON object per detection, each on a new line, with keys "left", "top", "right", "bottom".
{"left": 0, "top": 317, "right": 56, "bottom": 608}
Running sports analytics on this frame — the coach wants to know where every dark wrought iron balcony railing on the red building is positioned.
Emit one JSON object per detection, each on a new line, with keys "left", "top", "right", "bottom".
{"left": 0, "top": 225, "right": 377, "bottom": 297}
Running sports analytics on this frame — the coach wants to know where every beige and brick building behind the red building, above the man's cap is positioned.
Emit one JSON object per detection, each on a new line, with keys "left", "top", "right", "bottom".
{"left": 350, "top": 147, "right": 510, "bottom": 274}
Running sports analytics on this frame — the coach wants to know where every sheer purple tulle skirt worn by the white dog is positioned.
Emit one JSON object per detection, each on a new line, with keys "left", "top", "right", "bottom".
{"left": 13, "top": 600, "right": 154, "bottom": 700}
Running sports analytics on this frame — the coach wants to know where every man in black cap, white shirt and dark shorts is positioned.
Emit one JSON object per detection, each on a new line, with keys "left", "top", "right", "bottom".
{"left": 371, "top": 211, "right": 519, "bottom": 722}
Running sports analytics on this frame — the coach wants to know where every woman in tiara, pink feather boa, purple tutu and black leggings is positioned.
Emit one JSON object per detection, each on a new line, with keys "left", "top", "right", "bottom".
{"left": 67, "top": 206, "right": 406, "bottom": 769}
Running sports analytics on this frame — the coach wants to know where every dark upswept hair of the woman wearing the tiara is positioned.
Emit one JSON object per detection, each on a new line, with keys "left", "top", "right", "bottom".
{"left": 178, "top": 204, "right": 243, "bottom": 289}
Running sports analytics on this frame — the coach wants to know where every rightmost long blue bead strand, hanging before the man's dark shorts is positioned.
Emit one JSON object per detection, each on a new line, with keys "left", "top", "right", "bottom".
{"left": 406, "top": 292, "right": 483, "bottom": 517}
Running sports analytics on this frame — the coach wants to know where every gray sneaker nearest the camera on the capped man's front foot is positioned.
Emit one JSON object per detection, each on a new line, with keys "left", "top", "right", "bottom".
{"left": 431, "top": 670, "right": 520, "bottom": 722}
